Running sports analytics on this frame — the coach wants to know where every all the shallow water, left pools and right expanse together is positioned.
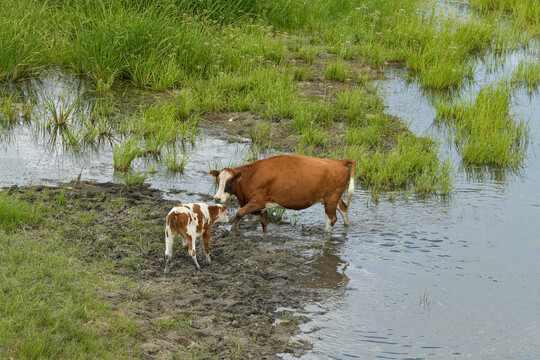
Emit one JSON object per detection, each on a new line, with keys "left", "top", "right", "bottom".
{"left": 0, "top": 32, "right": 540, "bottom": 359}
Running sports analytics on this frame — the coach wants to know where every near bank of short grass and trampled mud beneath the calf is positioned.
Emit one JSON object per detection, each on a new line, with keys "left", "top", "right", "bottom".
{"left": 0, "top": 181, "right": 322, "bottom": 359}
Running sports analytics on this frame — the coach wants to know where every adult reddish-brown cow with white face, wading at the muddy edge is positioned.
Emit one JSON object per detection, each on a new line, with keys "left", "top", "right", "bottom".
{"left": 210, "top": 155, "right": 356, "bottom": 232}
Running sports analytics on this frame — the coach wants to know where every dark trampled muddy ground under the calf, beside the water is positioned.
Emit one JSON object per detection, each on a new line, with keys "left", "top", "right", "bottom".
{"left": 9, "top": 181, "right": 342, "bottom": 359}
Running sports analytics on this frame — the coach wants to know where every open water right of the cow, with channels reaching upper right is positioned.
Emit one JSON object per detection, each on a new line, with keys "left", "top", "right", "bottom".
{"left": 285, "top": 36, "right": 540, "bottom": 359}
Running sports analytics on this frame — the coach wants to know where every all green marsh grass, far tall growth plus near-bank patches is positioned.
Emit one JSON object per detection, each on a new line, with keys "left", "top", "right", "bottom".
{"left": 0, "top": 0, "right": 540, "bottom": 358}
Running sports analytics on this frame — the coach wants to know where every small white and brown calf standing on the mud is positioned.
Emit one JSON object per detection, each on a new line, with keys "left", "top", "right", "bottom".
{"left": 165, "top": 204, "right": 229, "bottom": 274}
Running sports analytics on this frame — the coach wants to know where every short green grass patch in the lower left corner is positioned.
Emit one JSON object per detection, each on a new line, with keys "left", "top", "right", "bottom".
{"left": 0, "top": 192, "right": 136, "bottom": 359}
